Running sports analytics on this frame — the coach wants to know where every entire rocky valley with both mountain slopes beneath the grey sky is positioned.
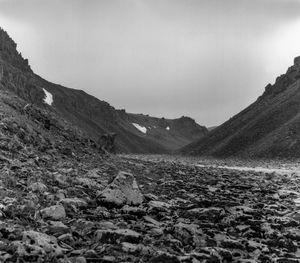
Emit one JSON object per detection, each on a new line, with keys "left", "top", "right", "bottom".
{"left": 0, "top": 8, "right": 300, "bottom": 263}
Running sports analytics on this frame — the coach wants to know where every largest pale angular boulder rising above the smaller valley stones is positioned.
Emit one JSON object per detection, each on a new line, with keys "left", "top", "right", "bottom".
{"left": 98, "top": 172, "right": 144, "bottom": 207}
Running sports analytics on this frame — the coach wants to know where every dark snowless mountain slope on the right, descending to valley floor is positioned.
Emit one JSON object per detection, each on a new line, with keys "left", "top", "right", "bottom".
{"left": 181, "top": 57, "right": 300, "bottom": 158}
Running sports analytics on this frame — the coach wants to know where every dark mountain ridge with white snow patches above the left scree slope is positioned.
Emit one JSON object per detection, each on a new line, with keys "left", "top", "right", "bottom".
{"left": 0, "top": 29, "right": 207, "bottom": 153}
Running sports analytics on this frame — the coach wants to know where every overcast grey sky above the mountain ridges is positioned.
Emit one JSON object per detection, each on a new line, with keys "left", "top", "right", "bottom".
{"left": 0, "top": 0, "right": 300, "bottom": 127}
